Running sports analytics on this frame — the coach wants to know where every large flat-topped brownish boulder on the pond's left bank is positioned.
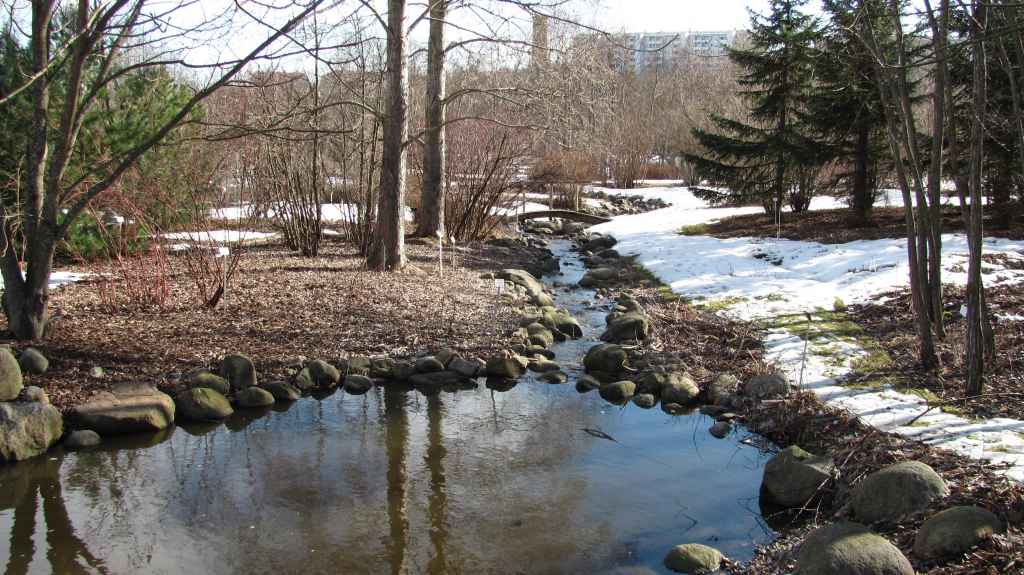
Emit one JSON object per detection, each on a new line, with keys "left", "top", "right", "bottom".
{"left": 72, "top": 384, "right": 174, "bottom": 435}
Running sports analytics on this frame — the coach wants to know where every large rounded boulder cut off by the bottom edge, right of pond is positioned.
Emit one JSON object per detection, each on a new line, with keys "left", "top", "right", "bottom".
{"left": 794, "top": 522, "right": 913, "bottom": 575}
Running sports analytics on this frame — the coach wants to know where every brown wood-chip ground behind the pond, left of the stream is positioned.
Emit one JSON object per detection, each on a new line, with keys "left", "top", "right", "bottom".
{"left": 0, "top": 236, "right": 539, "bottom": 409}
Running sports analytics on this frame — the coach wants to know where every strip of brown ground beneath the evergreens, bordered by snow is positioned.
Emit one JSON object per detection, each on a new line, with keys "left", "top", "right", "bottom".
{"left": 696, "top": 208, "right": 1024, "bottom": 244}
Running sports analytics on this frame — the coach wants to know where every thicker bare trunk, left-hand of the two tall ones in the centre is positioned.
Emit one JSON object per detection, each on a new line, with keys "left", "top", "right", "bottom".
{"left": 367, "top": 0, "right": 409, "bottom": 270}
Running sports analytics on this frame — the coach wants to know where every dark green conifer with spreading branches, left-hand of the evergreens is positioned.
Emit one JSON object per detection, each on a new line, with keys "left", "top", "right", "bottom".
{"left": 687, "top": 0, "right": 823, "bottom": 216}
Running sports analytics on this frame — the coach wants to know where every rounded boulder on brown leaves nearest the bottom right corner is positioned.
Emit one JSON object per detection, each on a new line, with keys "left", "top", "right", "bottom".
{"left": 913, "top": 505, "right": 1004, "bottom": 561}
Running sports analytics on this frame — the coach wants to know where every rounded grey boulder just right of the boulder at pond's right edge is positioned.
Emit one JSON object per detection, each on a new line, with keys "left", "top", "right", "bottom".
{"left": 850, "top": 461, "right": 949, "bottom": 523}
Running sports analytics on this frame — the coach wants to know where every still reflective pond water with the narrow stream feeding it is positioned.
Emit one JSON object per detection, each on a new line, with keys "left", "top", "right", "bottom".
{"left": 0, "top": 240, "right": 772, "bottom": 574}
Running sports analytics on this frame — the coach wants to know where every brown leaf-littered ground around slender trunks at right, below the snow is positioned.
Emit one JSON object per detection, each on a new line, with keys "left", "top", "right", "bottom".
{"left": 848, "top": 285, "right": 1024, "bottom": 419}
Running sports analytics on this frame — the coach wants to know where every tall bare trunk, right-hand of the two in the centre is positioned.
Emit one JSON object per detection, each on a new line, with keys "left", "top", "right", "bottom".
{"left": 416, "top": 0, "right": 447, "bottom": 236}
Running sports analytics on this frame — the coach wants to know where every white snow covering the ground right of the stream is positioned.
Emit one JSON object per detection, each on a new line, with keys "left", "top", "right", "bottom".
{"left": 591, "top": 187, "right": 1024, "bottom": 481}
